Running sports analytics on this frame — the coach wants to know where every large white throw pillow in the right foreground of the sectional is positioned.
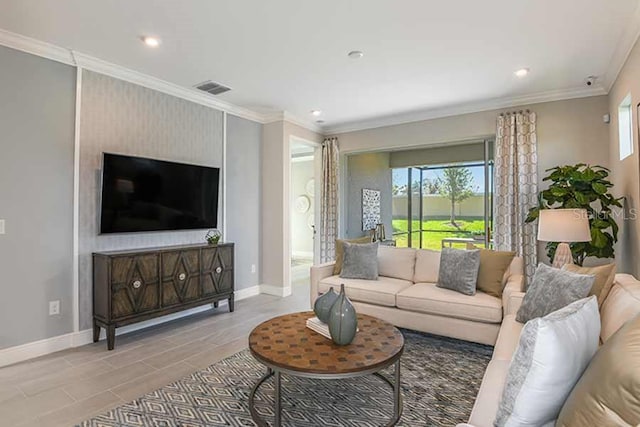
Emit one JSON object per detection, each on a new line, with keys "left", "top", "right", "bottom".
{"left": 494, "top": 296, "right": 600, "bottom": 427}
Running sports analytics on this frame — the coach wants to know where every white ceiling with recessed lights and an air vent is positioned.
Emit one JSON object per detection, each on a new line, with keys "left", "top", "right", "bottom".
{"left": 0, "top": 0, "right": 639, "bottom": 130}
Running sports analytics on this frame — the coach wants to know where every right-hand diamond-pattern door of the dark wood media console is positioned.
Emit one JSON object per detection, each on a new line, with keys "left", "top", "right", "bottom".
{"left": 202, "top": 246, "right": 233, "bottom": 296}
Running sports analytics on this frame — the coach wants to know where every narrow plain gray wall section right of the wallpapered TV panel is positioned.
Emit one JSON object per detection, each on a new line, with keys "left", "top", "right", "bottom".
{"left": 225, "top": 115, "right": 262, "bottom": 289}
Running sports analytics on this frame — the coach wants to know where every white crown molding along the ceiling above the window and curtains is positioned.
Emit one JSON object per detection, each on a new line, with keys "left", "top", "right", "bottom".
{"left": 324, "top": 85, "right": 608, "bottom": 135}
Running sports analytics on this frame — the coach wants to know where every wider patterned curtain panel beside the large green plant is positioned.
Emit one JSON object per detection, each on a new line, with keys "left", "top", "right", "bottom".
{"left": 493, "top": 111, "right": 538, "bottom": 283}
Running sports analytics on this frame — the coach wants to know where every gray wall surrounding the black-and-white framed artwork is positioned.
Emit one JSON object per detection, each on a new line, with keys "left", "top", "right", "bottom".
{"left": 344, "top": 153, "right": 393, "bottom": 238}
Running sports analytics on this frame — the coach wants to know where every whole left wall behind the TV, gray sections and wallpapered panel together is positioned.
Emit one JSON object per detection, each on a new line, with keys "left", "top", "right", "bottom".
{"left": 0, "top": 41, "right": 263, "bottom": 352}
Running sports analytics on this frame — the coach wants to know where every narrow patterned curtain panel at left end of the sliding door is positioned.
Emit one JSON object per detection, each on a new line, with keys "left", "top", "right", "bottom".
{"left": 320, "top": 138, "right": 339, "bottom": 262}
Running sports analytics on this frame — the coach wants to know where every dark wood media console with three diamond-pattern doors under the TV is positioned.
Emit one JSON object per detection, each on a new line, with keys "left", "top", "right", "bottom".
{"left": 93, "top": 243, "right": 234, "bottom": 350}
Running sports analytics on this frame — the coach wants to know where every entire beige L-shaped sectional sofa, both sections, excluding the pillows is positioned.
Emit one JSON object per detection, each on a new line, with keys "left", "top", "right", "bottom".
{"left": 311, "top": 247, "right": 640, "bottom": 427}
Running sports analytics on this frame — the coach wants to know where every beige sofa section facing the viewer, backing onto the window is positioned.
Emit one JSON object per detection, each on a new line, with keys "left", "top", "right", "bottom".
{"left": 311, "top": 246, "right": 523, "bottom": 345}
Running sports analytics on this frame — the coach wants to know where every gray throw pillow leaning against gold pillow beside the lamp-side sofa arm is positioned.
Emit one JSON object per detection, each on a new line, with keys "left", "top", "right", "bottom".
{"left": 436, "top": 248, "right": 480, "bottom": 295}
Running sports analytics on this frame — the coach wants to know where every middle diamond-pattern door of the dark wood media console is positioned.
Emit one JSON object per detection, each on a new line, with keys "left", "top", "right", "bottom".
{"left": 162, "top": 249, "right": 201, "bottom": 307}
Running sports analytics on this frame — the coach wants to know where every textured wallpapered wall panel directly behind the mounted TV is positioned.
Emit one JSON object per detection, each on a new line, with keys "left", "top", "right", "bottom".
{"left": 79, "top": 71, "right": 223, "bottom": 329}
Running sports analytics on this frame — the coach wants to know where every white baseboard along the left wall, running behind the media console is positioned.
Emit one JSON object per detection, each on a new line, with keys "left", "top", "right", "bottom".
{"left": 0, "top": 285, "right": 260, "bottom": 368}
